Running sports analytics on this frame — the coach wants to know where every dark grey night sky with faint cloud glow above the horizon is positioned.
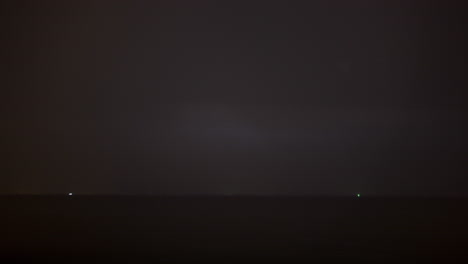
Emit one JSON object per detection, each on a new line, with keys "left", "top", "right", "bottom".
{"left": 0, "top": 0, "right": 468, "bottom": 195}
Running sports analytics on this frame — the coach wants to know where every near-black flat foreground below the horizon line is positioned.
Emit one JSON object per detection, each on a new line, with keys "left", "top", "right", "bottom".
{"left": 0, "top": 196, "right": 468, "bottom": 263}
